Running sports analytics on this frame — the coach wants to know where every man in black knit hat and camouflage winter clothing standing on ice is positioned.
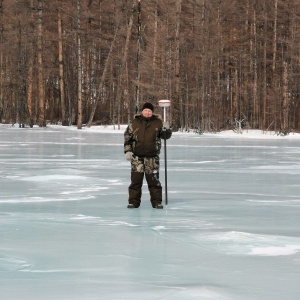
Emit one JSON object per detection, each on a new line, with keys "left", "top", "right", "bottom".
{"left": 124, "top": 102, "right": 172, "bottom": 209}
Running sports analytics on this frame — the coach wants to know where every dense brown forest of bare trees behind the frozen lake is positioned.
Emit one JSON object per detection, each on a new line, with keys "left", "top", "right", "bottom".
{"left": 0, "top": 0, "right": 300, "bottom": 133}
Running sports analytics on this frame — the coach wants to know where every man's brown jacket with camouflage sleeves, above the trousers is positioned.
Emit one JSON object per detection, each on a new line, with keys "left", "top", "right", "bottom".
{"left": 124, "top": 115, "right": 172, "bottom": 157}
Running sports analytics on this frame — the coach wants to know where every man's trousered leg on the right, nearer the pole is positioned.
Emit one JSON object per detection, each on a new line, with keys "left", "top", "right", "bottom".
{"left": 145, "top": 156, "right": 162, "bottom": 207}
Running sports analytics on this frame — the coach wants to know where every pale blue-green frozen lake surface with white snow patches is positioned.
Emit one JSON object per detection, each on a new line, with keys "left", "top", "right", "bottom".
{"left": 0, "top": 125, "right": 300, "bottom": 300}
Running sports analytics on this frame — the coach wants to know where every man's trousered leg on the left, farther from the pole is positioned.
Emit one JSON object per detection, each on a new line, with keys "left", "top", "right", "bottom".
{"left": 128, "top": 157, "right": 144, "bottom": 208}
